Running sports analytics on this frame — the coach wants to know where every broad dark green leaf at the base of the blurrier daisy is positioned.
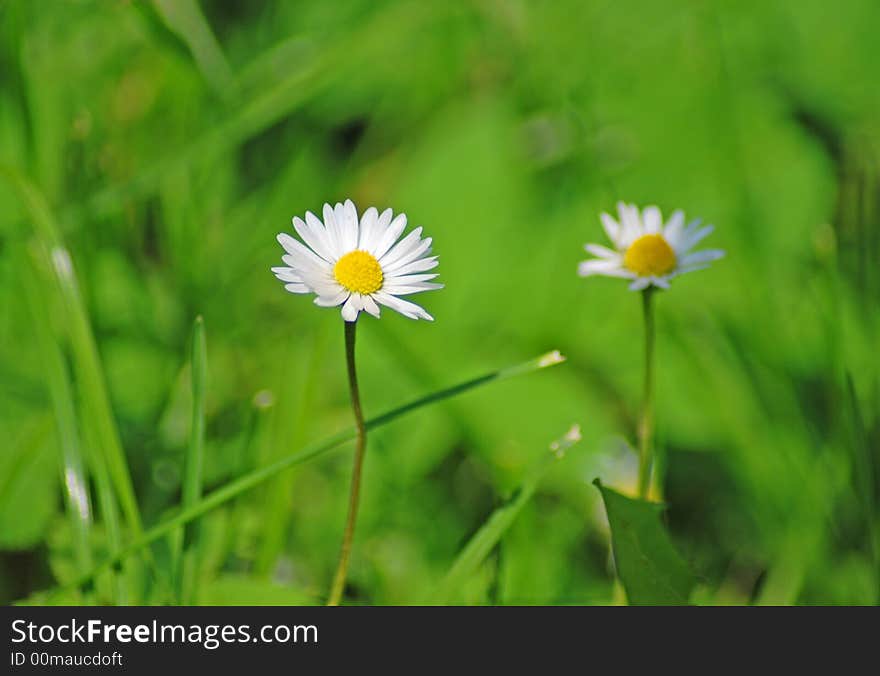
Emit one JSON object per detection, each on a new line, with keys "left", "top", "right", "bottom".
{"left": 593, "top": 479, "right": 696, "bottom": 606}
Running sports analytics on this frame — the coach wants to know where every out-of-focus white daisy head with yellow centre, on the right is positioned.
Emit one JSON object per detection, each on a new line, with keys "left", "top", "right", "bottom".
{"left": 578, "top": 202, "right": 724, "bottom": 291}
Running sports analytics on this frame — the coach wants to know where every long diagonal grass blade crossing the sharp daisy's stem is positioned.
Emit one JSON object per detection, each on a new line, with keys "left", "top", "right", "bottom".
{"left": 41, "top": 351, "right": 565, "bottom": 594}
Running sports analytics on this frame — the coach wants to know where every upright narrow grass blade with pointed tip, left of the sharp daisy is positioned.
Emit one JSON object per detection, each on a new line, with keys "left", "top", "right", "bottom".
{"left": 174, "top": 316, "right": 208, "bottom": 605}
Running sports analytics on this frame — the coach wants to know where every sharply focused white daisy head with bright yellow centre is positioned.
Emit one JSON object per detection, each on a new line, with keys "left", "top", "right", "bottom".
{"left": 272, "top": 200, "right": 443, "bottom": 322}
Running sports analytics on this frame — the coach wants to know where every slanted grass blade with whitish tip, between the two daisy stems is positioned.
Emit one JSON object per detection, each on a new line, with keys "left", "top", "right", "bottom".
{"left": 428, "top": 425, "right": 581, "bottom": 605}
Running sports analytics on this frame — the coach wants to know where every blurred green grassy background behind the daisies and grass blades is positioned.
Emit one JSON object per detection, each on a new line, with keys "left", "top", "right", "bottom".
{"left": 0, "top": 0, "right": 880, "bottom": 604}
